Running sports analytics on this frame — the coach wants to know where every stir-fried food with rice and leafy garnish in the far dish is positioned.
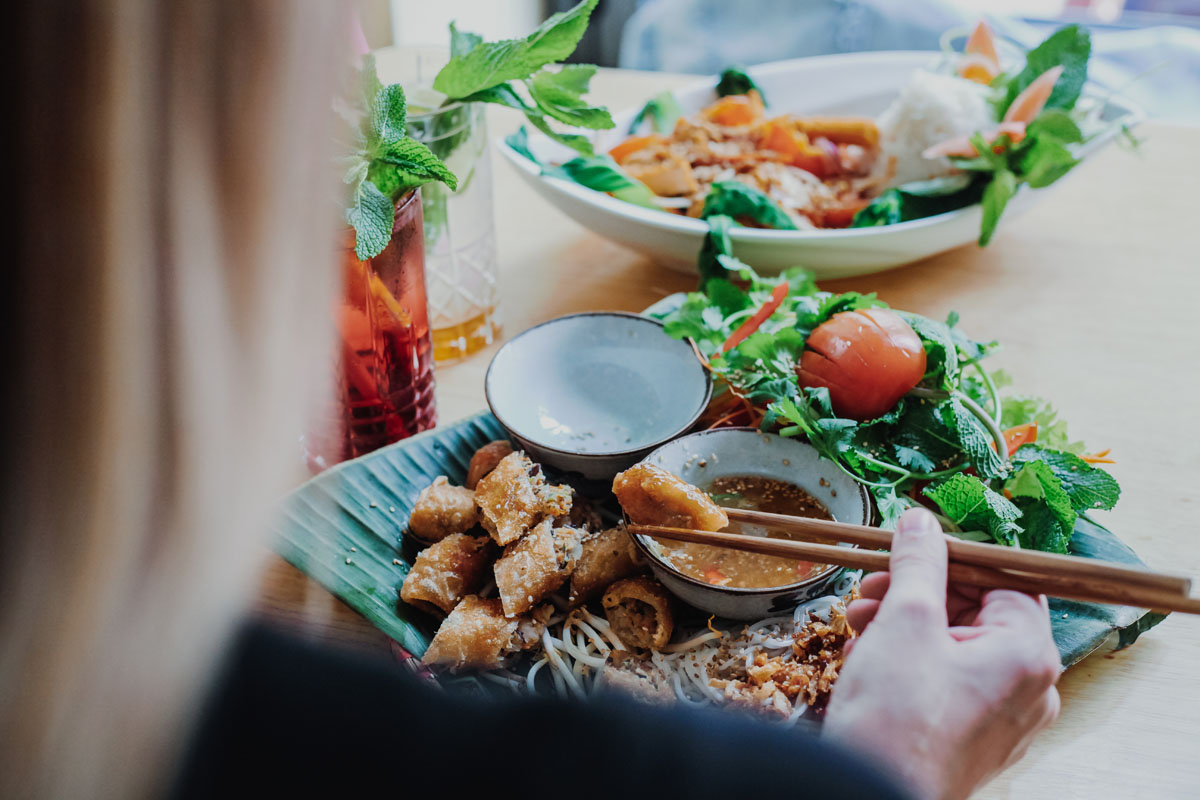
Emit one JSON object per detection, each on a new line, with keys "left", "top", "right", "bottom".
{"left": 508, "top": 22, "right": 1113, "bottom": 245}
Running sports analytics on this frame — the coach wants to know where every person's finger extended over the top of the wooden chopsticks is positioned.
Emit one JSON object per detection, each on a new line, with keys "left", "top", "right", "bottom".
{"left": 877, "top": 509, "right": 947, "bottom": 628}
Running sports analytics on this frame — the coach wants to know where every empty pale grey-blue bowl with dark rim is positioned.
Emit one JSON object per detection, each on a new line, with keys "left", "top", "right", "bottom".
{"left": 484, "top": 312, "right": 713, "bottom": 481}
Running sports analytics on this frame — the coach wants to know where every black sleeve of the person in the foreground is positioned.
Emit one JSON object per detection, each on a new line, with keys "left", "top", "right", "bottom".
{"left": 172, "top": 626, "right": 908, "bottom": 800}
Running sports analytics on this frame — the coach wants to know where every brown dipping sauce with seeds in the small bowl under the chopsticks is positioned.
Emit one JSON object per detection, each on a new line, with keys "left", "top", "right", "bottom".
{"left": 655, "top": 475, "right": 833, "bottom": 589}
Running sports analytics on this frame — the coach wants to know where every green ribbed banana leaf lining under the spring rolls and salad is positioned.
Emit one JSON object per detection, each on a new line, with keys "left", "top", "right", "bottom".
{"left": 274, "top": 413, "right": 1163, "bottom": 667}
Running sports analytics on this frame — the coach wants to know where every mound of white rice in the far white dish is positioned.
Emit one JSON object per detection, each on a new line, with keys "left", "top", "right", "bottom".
{"left": 878, "top": 70, "right": 996, "bottom": 186}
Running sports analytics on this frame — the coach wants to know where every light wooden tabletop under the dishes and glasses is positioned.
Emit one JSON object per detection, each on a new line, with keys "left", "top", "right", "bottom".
{"left": 258, "top": 61, "right": 1200, "bottom": 800}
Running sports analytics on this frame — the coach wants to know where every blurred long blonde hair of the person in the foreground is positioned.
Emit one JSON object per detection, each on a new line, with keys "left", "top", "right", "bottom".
{"left": 0, "top": 0, "right": 346, "bottom": 798}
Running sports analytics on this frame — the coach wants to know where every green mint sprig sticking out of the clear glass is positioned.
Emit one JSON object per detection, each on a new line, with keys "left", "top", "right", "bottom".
{"left": 433, "top": 0, "right": 613, "bottom": 156}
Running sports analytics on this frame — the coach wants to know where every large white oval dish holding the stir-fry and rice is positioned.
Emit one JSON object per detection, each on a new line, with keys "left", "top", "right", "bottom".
{"left": 497, "top": 52, "right": 1142, "bottom": 278}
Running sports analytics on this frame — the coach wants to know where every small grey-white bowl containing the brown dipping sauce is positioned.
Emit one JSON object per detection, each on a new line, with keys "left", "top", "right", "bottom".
{"left": 634, "top": 428, "right": 872, "bottom": 620}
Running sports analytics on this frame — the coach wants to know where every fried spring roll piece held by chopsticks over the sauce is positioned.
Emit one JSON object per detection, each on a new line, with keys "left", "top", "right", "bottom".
{"left": 612, "top": 463, "right": 730, "bottom": 530}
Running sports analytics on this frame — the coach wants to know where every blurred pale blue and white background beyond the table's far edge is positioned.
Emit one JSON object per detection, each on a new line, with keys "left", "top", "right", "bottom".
{"left": 360, "top": 0, "right": 1200, "bottom": 124}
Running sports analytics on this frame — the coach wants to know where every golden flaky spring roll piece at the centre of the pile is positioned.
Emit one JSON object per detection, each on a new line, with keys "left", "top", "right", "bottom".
{"left": 494, "top": 519, "right": 583, "bottom": 616}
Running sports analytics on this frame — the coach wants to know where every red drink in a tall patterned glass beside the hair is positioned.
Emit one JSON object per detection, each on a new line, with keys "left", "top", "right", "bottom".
{"left": 308, "top": 192, "right": 437, "bottom": 469}
